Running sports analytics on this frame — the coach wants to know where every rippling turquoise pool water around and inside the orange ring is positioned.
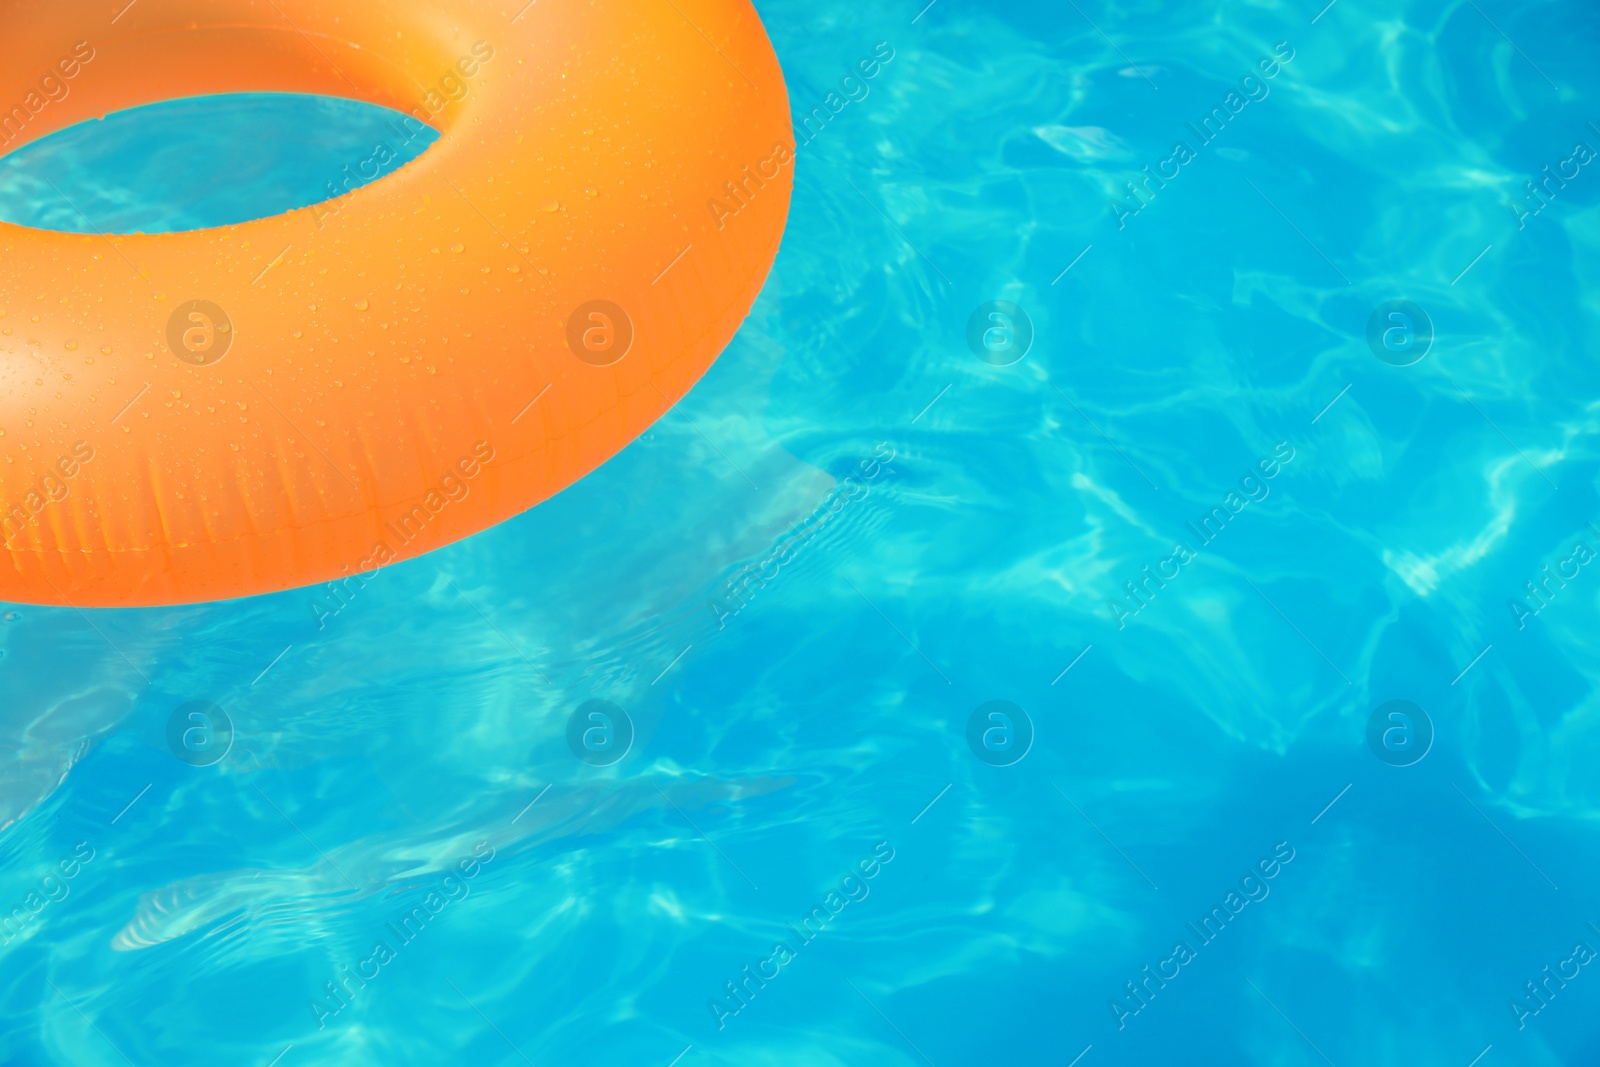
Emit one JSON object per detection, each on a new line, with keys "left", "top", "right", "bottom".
{"left": 0, "top": 0, "right": 1600, "bottom": 1067}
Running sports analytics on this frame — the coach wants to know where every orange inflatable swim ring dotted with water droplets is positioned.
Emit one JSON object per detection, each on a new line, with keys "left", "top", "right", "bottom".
{"left": 0, "top": 0, "right": 794, "bottom": 606}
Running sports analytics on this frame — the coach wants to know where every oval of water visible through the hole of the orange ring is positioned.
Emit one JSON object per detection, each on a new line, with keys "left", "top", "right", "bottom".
{"left": 0, "top": 93, "right": 438, "bottom": 234}
